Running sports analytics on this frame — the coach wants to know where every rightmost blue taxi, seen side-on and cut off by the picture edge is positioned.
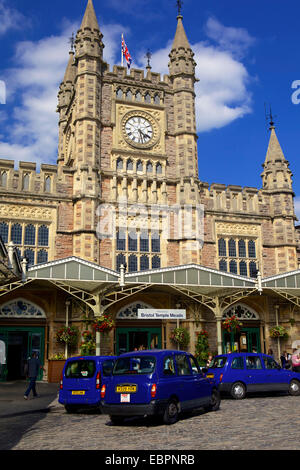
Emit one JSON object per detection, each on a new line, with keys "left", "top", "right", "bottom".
{"left": 206, "top": 353, "right": 300, "bottom": 400}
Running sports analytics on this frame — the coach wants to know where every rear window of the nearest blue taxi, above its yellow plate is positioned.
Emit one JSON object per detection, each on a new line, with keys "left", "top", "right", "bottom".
{"left": 113, "top": 355, "right": 156, "bottom": 375}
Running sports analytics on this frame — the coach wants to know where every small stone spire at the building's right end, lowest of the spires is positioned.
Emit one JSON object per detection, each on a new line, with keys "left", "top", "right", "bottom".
{"left": 261, "top": 122, "right": 292, "bottom": 194}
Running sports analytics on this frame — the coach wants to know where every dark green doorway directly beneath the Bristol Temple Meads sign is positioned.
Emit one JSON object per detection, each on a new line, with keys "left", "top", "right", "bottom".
{"left": 116, "top": 328, "right": 161, "bottom": 354}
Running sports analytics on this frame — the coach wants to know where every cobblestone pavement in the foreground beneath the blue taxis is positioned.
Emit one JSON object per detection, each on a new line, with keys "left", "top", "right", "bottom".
{"left": 0, "top": 382, "right": 300, "bottom": 451}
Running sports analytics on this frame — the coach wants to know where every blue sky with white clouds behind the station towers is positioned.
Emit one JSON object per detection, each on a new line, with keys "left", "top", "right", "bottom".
{"left": 0, "top": 0, "right": 300, "bottom": 218}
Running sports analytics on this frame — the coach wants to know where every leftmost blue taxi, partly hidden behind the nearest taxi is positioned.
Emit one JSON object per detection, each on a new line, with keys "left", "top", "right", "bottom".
{"left": 58, "top": 356, "right": 116, "bottom": 413}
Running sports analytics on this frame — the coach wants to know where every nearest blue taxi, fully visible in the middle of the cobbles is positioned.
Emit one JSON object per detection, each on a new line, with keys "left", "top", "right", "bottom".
{"left": 100, "top": 349, "right": 220, "bottom": 424}
